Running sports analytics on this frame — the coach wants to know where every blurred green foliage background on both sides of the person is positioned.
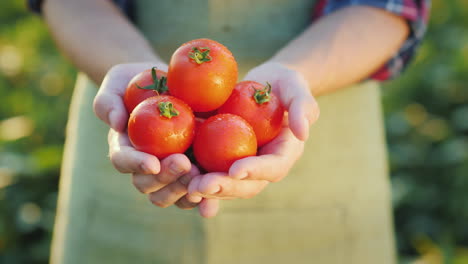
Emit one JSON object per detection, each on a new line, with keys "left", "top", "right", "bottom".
{"left": 0, "top": 0, "right": 468, "bottom": 264}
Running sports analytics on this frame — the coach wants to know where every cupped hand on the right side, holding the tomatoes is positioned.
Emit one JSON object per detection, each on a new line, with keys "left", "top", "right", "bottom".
{"left": 188, "top": 62, "right": 320, "bottom": 214}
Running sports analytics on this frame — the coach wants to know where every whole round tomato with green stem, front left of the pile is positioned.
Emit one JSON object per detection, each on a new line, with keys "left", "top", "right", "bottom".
{"left": 128, "top": 95, "right": 195, "bottom": 159}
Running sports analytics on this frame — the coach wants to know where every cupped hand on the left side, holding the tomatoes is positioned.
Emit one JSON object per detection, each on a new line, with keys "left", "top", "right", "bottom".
{"left": 94, "top": 63, "right": 218, "bottom": 217}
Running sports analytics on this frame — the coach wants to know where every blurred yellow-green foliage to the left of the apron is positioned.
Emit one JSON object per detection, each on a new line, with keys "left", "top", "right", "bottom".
{"left": 0, "top": 0, "right": 75, "bottom": 263}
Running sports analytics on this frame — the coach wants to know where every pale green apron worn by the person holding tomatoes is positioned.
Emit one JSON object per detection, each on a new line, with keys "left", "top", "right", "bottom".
{"left": 51, "top": 0, "right": 396, "bottom": 264}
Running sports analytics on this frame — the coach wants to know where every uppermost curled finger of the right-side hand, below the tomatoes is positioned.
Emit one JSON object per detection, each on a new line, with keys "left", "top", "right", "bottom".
{"left": 229, "top": 128, "right": 304, "bottom": 182}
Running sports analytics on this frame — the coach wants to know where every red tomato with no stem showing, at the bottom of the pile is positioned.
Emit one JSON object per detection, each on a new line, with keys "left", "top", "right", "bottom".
{"left": 193, "top": 114, "right": 257, "bottom": 172}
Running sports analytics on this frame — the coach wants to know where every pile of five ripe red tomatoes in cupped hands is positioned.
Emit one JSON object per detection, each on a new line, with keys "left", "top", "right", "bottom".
{"left": 124, "top": 39, "right": 284, "bottom": 172}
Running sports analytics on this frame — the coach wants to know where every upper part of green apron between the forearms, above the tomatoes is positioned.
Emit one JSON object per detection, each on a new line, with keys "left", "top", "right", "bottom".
{"left": 135, "top": 0, "right": 314, "bottom": 77}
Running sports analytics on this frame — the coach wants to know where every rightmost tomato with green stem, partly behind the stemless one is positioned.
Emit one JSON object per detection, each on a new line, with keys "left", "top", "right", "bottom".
{"left": 218, "top": 81, "right": 284, "bottom": 147}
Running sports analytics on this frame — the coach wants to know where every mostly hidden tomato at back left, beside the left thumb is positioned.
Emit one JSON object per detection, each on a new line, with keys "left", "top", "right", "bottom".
{"left": 123, "top": 68, "right": 168, "bottom": 114}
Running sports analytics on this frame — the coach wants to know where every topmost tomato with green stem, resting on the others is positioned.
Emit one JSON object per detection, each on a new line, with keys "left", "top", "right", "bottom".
{"left": 167, "top": 39, "right": 237, "bottom": 112}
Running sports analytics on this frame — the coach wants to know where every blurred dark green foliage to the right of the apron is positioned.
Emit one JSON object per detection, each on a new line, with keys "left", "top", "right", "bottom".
{"left": 383, "top": 0, "right": 468, "bottom": 263}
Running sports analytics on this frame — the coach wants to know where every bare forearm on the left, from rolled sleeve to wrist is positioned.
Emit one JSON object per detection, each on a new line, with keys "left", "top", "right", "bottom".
{"left": 43, "top": 0, "right": 160, "bottom": 84}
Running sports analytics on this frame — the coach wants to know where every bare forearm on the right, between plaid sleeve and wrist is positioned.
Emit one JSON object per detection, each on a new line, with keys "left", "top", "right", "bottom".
{"left": 272, "top": 6, "right": 409, "bottom": 95}
